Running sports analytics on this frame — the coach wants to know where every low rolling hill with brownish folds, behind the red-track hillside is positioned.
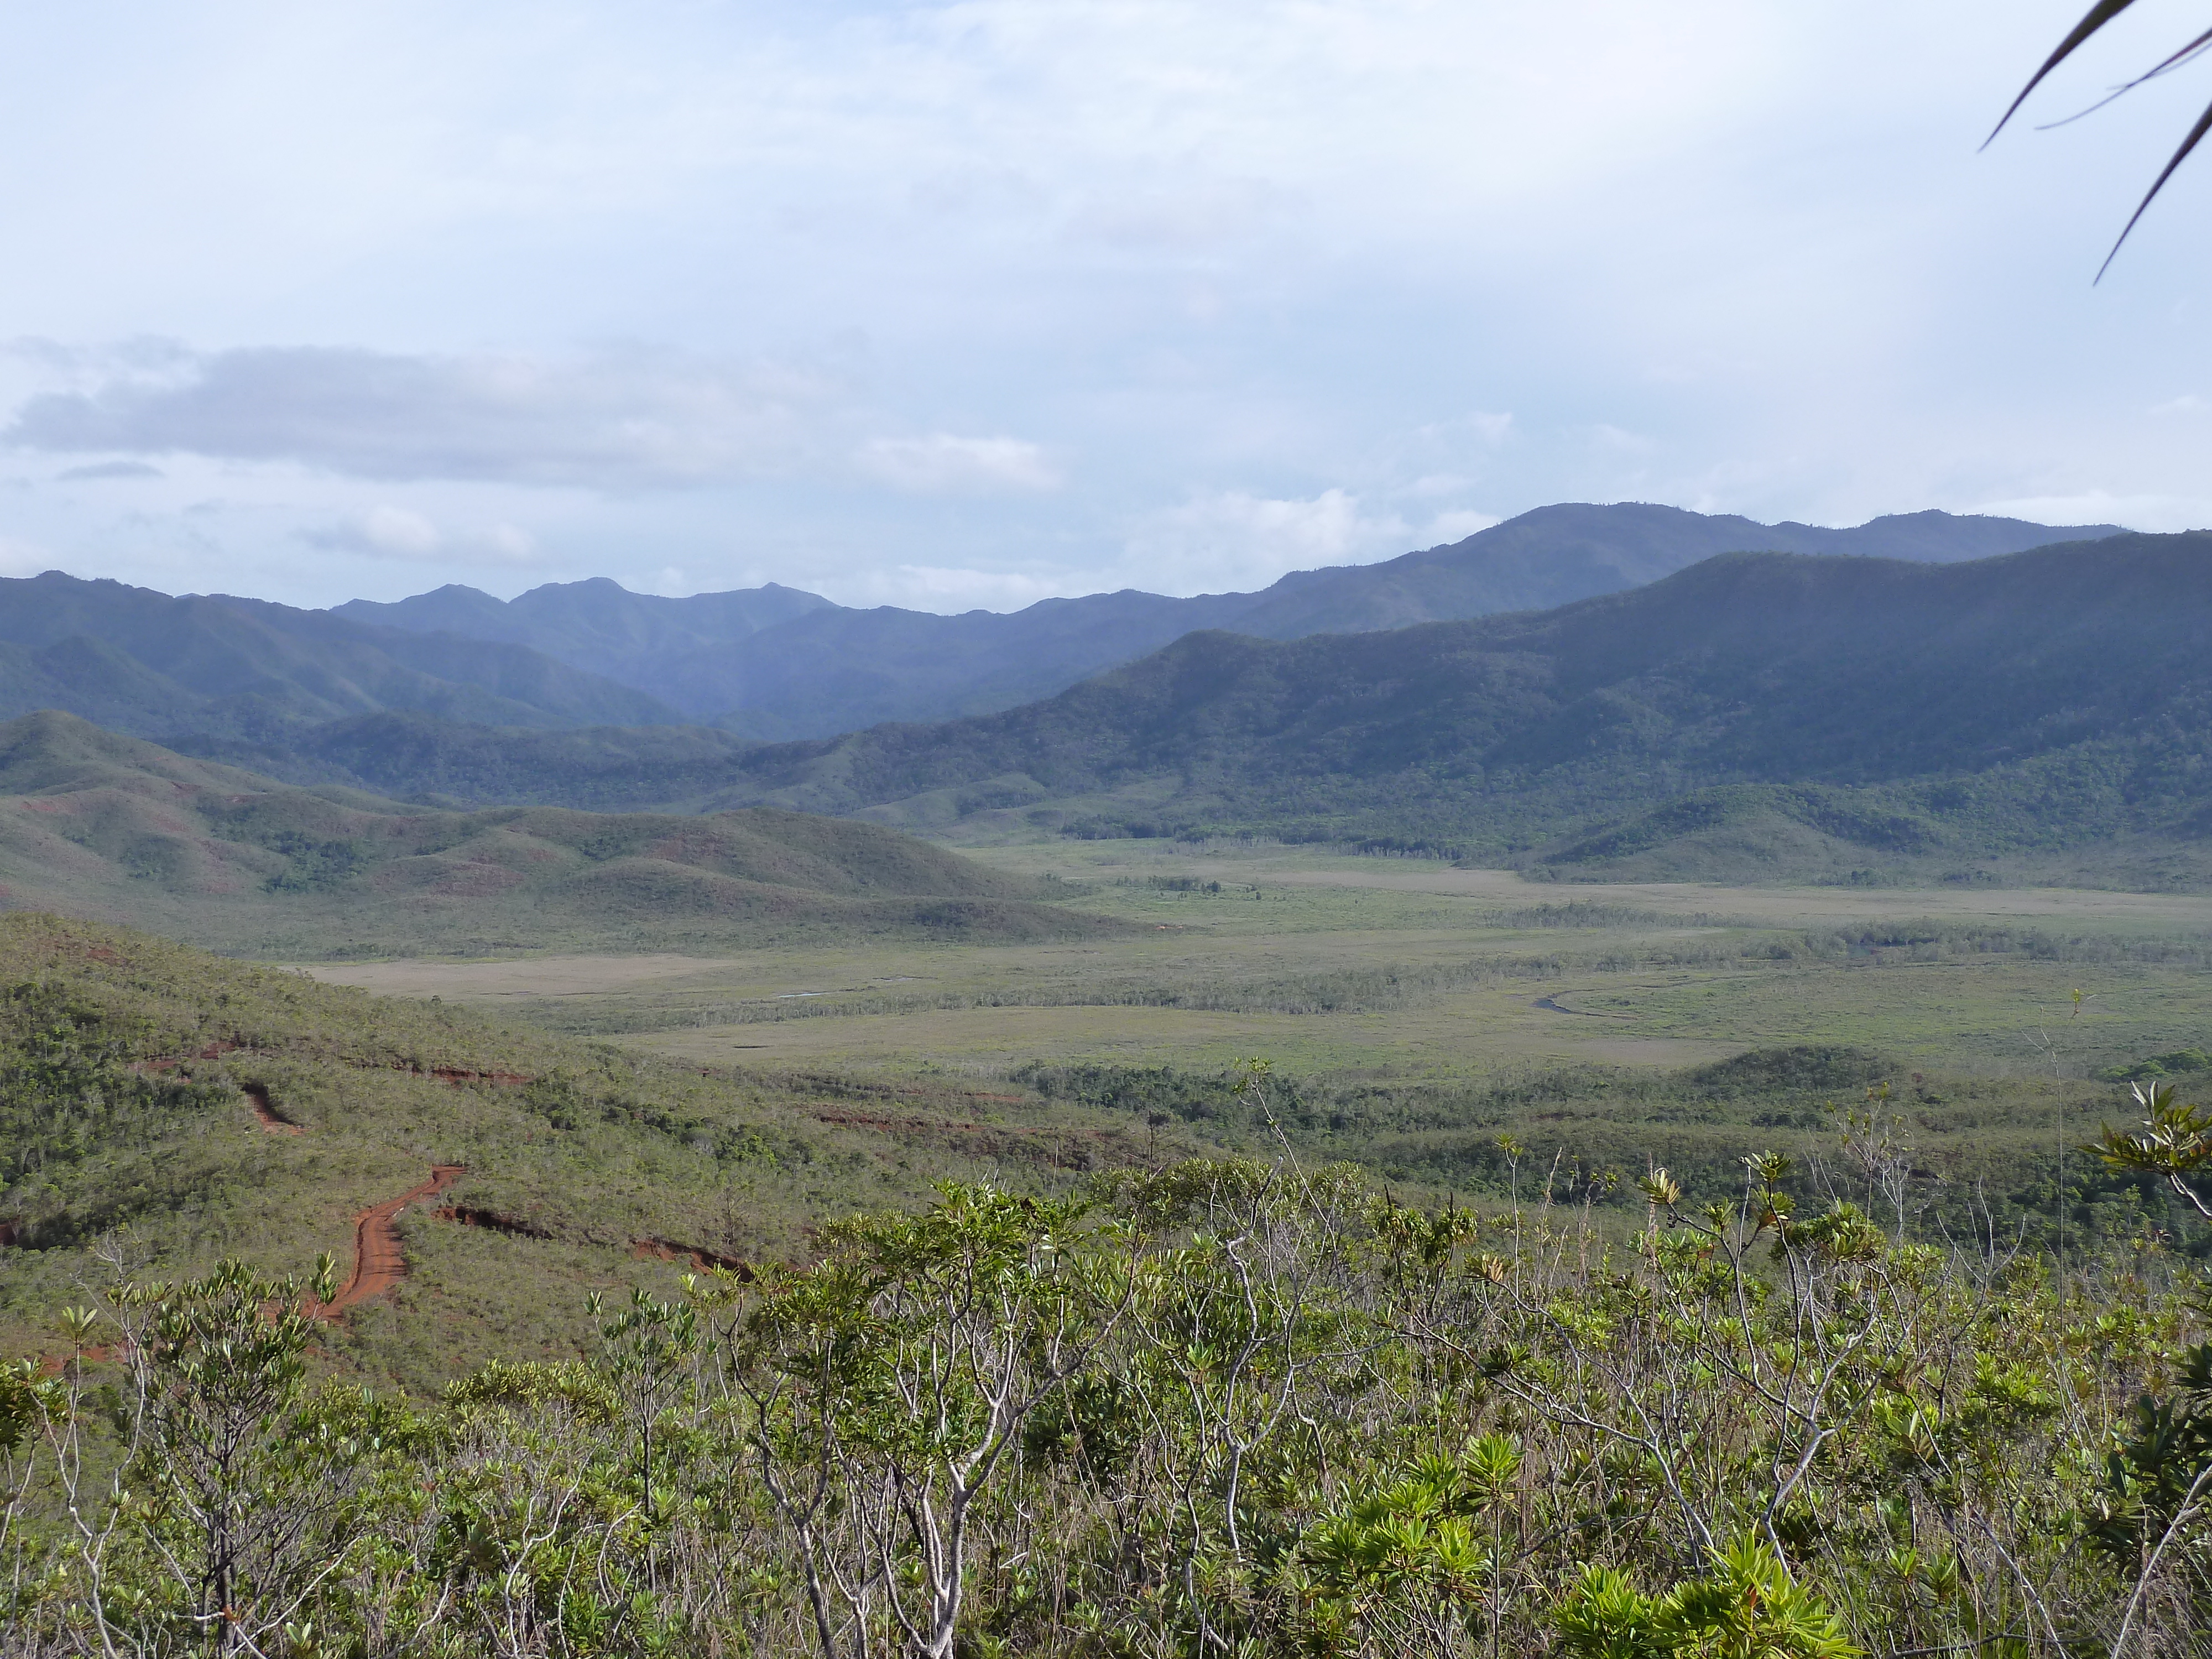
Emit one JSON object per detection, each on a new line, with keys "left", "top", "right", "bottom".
{"left": 0, "top": 712, "right": 1117, "bottom": 958}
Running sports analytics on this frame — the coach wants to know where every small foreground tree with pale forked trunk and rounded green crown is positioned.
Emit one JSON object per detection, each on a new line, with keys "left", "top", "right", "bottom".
{"left": 739, "top": 1183, "right": 1133, "bottom": 1659}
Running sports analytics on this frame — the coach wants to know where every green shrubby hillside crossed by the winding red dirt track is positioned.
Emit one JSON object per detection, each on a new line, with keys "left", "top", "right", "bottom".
{"left": 0, "top": 914, "right": 1148, "bottom": 1389}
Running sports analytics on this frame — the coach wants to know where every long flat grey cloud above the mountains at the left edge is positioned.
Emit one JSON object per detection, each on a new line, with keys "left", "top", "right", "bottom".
{"left": 0, "top": 345, "right": 847, "bottom": 489}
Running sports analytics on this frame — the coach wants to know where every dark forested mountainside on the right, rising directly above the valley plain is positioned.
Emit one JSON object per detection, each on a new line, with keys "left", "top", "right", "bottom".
{"left": 703, "top": 533, "right": 2212, "bottom": 876}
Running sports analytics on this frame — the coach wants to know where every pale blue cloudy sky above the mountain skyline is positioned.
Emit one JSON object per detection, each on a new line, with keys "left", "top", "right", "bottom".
{"left": 0, "top": 0, "right": 2212, "bottom": 611}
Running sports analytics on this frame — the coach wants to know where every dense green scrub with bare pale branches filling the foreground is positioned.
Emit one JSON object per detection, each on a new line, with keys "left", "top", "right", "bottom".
{"left": 0, "top": 1141, "right": 2212, "bottom": 1659}
